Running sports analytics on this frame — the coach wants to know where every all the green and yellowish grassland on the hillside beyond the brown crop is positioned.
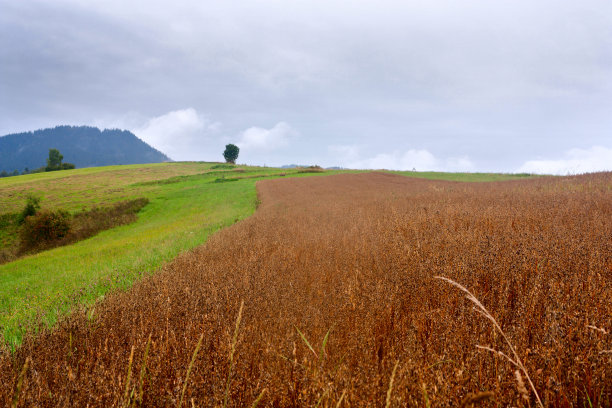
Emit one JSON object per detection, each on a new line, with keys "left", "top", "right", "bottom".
{"left": 0, "top": 162, "right": 524, "bottom": 348}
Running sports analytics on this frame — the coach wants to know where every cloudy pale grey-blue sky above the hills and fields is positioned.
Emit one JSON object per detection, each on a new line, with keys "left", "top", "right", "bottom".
{"left": 0, "top": 0, "right": 612, "bottom": 174}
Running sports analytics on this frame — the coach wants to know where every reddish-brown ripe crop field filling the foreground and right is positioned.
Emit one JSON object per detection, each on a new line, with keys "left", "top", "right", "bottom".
{"left": 0, "top": 173, "right": 612, "bottom": 407}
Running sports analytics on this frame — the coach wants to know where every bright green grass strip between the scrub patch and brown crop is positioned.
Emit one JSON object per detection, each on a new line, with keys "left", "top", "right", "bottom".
{"left": 0, "top": 166, "right": 257, "bottom": 348}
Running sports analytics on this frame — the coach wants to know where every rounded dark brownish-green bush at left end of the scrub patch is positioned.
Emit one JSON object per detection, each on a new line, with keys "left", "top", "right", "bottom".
{"left": 20, "top": 210, "right": 70, "bottom": 252}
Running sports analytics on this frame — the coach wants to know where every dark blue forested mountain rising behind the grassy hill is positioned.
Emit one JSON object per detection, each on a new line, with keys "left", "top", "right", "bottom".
{"left": 0, "top": 126, "right": 170, "bottom": 172}
